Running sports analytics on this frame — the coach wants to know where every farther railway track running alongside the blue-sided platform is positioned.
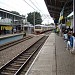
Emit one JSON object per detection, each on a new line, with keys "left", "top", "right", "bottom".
{"left": 0, "top": 36, "right": 33, "bottom": 51}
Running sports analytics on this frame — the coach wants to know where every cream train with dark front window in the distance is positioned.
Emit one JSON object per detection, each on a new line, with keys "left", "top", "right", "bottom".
{"left": 34, "top": 25, "right": 55, "bottom": 34}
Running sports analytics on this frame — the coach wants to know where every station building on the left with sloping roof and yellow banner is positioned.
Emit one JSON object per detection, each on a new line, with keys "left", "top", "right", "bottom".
{"left": 0, "top": 8, "right": 25, "bottom": 34}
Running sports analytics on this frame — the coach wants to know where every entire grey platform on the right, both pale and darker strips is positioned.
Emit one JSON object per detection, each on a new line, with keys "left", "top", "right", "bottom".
{"left": 25, "top": 33, "right": 75, "bottom": 75}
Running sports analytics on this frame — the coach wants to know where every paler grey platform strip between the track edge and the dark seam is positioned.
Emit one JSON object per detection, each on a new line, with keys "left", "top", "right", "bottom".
{"left": 25, "top": 33, "right": 56, "bottom": 75}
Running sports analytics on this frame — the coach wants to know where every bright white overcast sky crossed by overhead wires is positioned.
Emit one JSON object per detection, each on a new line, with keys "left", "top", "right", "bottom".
{"left": 0, "top": 0, "right": 54, "bottom": 24}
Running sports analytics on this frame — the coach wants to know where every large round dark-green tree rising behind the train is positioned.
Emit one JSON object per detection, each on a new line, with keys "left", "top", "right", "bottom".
{"left": 27, "top": 12, "right": 42, "bottom": 25}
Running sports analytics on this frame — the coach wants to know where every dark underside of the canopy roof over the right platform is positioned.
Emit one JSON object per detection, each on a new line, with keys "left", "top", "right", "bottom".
{"left": 44, "top": 0, "right": 73, "bottom": 19}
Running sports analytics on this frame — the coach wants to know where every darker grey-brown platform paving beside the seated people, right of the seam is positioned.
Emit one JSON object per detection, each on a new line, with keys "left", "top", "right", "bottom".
{"left": 55, "top": 35, "right": 75, "bottom": 75}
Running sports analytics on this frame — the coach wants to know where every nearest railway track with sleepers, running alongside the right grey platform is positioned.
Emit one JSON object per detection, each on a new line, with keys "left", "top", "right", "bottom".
{"left": 0, "top": 36, "right": 48, "bottom": 75}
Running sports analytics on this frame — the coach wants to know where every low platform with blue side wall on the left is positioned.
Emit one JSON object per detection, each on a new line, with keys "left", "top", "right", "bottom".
{"left": 0, "top": 33, "right": 24, "bottom": 45}
